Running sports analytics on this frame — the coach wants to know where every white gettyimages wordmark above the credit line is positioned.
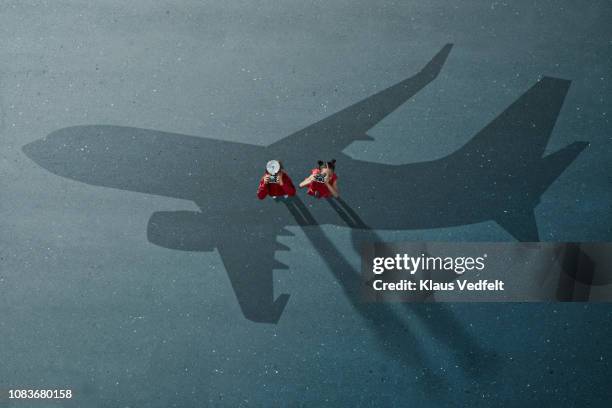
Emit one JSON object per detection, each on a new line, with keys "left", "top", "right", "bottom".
{"left": 372, "top": 253, "right": 487, "bottom": 275}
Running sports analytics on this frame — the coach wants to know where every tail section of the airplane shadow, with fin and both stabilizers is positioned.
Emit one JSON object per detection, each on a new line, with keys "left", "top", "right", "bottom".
{"left": 447, "top": 77, "right": 587, "bottom": 241}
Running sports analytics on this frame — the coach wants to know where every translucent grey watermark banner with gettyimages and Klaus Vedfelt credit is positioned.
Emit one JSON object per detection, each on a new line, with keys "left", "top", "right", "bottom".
{"left": 361, "top": 242, "right": 612, "bottom": 302}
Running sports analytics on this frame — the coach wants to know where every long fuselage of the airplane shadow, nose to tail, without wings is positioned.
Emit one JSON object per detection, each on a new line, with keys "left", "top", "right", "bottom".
{"left": 23, "top": 80, "right": 586, "bottom": 239}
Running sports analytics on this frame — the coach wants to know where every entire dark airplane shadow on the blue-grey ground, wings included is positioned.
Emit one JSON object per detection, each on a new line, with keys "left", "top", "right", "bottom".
{"left": 23, "top": 45, "right": 586, "bottom": 322}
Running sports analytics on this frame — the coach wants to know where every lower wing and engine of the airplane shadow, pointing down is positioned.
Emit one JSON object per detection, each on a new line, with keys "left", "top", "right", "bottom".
{"left": 147, "top": 211, "right": 289, "bottom": 323}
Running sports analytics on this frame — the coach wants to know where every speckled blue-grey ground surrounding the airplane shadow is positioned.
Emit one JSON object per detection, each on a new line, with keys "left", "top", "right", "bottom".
{"left": 0, "top": 0, "right": 612, "bottom": 407}
